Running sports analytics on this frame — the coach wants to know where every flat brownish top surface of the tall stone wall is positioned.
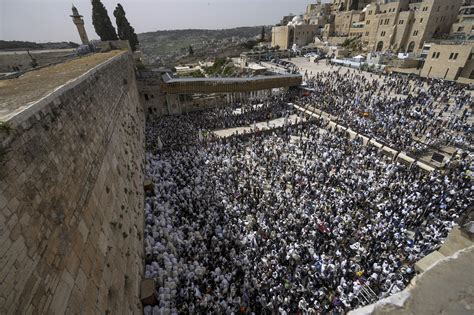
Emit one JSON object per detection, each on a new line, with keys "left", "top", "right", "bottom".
{"left": 0, "top": 50, "right": 124, "bottom": 121}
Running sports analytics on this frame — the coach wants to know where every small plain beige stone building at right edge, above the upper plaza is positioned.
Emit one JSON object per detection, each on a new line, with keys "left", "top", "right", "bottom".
{"left": 420, "top": 41, "right": 474, "bottom": 83}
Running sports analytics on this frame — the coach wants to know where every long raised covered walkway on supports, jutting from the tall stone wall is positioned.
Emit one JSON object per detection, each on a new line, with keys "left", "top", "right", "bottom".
{"left": 138, "top": 70, "right": 302, "bottom": 116}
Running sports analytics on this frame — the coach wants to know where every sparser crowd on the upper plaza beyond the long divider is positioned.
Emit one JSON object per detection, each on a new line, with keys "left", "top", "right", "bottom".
{"left": 299, "top": 70, "right": 473, "bottom": 154}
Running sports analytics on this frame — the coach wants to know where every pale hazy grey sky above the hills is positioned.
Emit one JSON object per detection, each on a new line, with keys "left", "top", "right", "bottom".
{"left": 0, "top": 0, "right": 324, "bottom": 43}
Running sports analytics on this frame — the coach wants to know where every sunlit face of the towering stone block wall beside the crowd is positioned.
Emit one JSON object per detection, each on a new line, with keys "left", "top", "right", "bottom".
{"left": 0, "top": 52, "right": 144, "bottom": 314}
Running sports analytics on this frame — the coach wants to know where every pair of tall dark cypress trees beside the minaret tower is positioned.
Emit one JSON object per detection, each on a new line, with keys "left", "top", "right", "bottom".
{"left": 92, "top": 0, "right": 138, "bottom": 51}
